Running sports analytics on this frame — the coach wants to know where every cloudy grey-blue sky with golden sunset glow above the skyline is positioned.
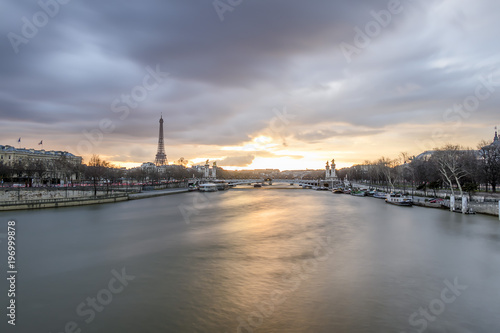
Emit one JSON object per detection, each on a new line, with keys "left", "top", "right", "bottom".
{"left": 0, "top": 0, "right": 500, "bottom": 169}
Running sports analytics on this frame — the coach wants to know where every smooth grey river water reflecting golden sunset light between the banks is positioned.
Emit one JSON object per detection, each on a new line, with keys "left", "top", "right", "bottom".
{"left": 0, "top": 188, "right": 500, "bottom": 333}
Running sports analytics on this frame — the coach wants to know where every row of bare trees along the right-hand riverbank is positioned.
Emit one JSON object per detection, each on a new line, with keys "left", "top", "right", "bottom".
{"left": 338, "top": 141, "right": 500, "bottom": 195}
